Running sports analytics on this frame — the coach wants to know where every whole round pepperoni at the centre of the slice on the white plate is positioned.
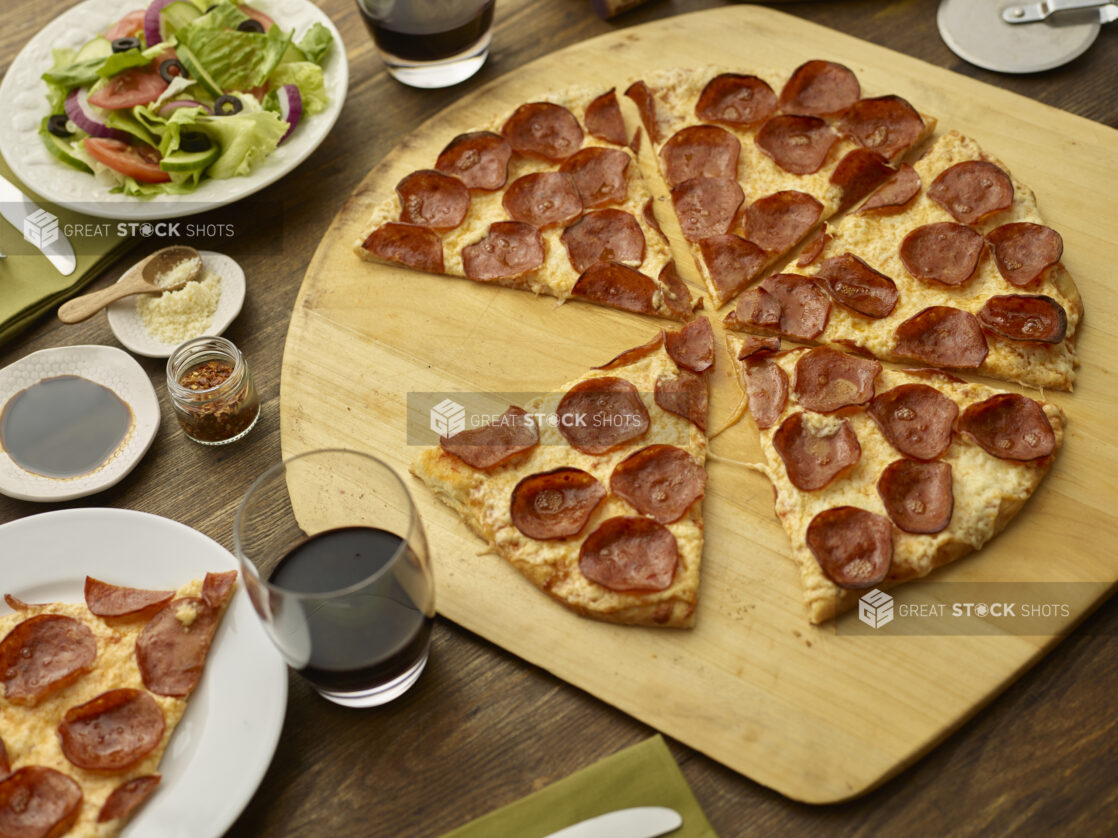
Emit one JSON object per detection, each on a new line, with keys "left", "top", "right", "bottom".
{"left": 58, "top": 689, "right": 165, "bottom": 771}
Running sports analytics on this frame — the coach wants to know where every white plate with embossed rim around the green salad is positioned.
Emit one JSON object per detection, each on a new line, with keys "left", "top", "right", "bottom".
{"left": 0, "top": 0, "right": 349, "bottom": 221}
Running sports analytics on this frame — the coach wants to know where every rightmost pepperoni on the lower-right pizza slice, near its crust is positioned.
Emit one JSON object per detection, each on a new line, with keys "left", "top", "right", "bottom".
{"left": 959, "top": 393, "right": 1055, "bottom": 461}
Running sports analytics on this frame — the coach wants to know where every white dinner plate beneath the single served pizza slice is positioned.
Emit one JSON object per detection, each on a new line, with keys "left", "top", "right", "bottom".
{"left": 0, "top": 508, "right": 287, "bottom": 838}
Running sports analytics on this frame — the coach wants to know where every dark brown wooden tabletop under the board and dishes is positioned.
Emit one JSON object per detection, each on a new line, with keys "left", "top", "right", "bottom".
{"left": 0, "top": 0, "right": 1118, "bottom": 838}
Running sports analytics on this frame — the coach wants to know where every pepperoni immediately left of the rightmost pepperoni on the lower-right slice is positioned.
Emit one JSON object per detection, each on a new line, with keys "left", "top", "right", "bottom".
{"left": 866, "top": 383, "right": 959, "bottom": 460}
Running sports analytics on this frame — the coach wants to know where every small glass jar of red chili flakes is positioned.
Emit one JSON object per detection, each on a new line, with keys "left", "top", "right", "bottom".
{"left": 167, "top": 335, "right": 260, "bottom": 445}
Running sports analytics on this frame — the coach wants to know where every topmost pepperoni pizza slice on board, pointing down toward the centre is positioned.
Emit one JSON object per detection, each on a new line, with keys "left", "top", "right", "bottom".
{"left": 626, "top": 60, "right": 935, "bottom": 307}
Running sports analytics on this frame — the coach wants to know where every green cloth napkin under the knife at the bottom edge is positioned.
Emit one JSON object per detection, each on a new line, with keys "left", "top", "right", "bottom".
{"left": 443, "top": 735, "right": 717, "bottom": 838}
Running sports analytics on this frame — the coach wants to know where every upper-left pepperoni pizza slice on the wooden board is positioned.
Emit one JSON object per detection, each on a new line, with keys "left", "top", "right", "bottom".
{"left": 354, "top": 89, "right": 697, "bottom": 320}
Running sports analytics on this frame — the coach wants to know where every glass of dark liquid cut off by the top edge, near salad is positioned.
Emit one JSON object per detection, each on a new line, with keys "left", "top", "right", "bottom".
{"left": 357, "top": 0, "right": 495, "bottom": 87}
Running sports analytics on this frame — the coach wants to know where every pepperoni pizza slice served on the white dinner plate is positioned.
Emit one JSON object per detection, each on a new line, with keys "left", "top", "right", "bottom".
{"left": 0, "top": 571, "right": 237, "bottom": 838}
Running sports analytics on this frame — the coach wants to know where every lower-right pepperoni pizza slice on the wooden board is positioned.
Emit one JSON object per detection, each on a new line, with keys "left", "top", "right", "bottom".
{"left": 729, "top": 337, "right": 1064, "bottom": 623}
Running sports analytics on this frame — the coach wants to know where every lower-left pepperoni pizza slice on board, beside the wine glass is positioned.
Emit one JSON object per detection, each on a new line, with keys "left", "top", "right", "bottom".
{"left": 411, "top": 317, "right": 714, "bottom": 628}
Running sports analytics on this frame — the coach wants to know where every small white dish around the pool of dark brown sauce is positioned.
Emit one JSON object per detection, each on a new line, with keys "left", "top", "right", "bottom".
{"left": 0, "top": 346, "right": 159, "bottom": 502}
